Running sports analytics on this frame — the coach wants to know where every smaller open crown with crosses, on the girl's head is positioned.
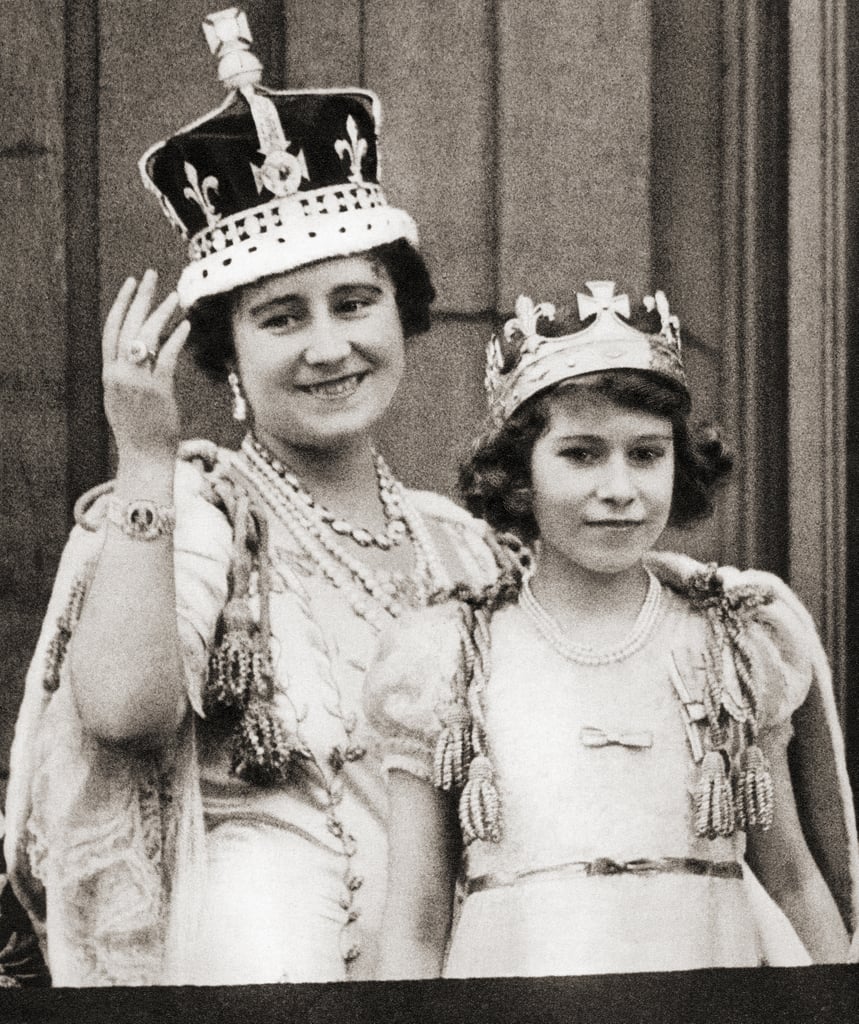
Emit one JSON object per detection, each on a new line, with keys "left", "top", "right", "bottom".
{"left": 485, "top": 281, "right": 686, "bottom": 425}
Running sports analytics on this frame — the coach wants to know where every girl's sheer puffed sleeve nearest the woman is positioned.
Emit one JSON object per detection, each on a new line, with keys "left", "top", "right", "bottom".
{"left": 363, "top": 603, "right": 460, "bottom": 781}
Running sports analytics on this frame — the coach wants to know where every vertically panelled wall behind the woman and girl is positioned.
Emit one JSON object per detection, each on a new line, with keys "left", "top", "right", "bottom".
{"left": 0, "top": 0, "right": 846, "bottom": 786}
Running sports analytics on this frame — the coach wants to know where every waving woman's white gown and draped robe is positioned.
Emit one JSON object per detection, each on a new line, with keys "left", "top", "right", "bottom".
{"left": 0, "top": 452, "right": 497, "bottom": 985}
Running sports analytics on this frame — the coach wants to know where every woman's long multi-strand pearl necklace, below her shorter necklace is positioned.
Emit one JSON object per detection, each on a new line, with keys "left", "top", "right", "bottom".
{"left": 238, "top": 437, "right": 449, "bottom": 629}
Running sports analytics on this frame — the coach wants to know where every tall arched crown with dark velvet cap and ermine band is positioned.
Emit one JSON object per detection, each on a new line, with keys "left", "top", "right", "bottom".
{"left": 139, "top": 7, "right": 418, "bottom": 308}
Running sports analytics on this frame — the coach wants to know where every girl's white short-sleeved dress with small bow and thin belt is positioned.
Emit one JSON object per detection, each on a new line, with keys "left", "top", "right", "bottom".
{"left": 366, "top": 561, "right": 856, "bottom": 977}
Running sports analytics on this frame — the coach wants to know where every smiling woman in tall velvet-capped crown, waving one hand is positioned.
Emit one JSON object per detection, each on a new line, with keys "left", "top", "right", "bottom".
{"left": 0, "top": 11, "right": 496, "bottom": 985}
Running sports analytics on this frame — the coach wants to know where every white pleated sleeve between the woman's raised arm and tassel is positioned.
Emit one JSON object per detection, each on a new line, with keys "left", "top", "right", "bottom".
{"left": 173, "top": 462, "right": 232, "bottom": 717}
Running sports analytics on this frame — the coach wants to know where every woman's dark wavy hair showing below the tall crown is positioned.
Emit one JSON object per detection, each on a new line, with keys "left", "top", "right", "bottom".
{"left": 185, "top": 239, "right": 435, "bottom": 380}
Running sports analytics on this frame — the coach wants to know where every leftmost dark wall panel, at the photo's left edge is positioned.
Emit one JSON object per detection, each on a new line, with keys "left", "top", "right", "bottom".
{"left": 0, "top": 0, "right": 70, "bottom": 798}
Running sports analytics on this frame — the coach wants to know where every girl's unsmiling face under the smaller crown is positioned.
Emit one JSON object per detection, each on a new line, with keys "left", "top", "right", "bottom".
{"left": 531, "top": 387, "right": 674, "bottom": 573}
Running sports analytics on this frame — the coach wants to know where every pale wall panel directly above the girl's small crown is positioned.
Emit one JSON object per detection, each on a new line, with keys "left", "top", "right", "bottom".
{"left": 499, "top": 0, "right": 651, "bottom": 306}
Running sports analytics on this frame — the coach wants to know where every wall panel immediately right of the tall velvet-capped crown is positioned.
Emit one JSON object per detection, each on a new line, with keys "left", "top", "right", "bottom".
{"left": 364, "top": 0, "right": 498, "bottom": 313}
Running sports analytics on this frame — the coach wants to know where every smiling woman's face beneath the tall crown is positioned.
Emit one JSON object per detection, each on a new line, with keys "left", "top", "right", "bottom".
{"left": 232, "top": 256, "right": 404, "bottom": 449}
